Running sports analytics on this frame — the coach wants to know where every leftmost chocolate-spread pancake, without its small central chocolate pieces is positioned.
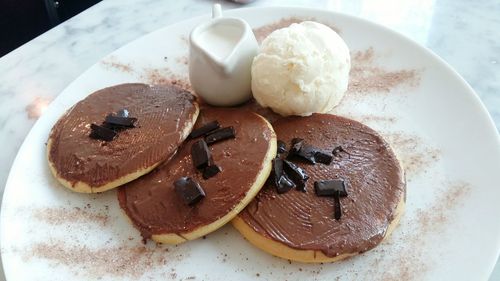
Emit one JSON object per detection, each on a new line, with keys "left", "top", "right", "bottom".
{"left": 47, "top": 84, "right": 199, "bottom": 193}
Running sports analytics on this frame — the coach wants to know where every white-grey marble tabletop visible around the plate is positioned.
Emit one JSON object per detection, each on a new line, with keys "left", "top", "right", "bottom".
{"left": 0, "top": 0, "right": 500, "bottom": 281}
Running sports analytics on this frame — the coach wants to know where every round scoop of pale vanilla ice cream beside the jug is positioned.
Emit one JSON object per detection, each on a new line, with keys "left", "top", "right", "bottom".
{"left": 252, "top": 21, "right": 351, "bottom": 116}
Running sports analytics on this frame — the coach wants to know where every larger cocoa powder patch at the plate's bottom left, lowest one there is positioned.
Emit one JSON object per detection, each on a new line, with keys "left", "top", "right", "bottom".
{"left": 24, "top": 241, "right": 180, "bottom": 279}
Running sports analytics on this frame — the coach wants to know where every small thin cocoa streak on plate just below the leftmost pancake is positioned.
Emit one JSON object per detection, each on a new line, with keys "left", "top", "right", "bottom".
{"left": 33, "top": 207, "right": 109, "bottom": 226}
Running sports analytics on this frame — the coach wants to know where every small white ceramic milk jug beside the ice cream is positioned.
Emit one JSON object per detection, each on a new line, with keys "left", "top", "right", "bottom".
{"left": 189, "top": 4, "right": 259, "bottom": 106}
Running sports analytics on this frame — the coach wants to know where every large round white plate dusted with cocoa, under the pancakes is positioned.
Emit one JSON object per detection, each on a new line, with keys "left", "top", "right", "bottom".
{"left": 1, "top": 8, "right": 500, "bottom": 280}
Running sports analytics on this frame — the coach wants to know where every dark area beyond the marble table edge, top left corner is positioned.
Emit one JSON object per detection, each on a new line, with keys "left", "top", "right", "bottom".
{"left": 0, "top": 0, "right": 101, "bottom": 57}
